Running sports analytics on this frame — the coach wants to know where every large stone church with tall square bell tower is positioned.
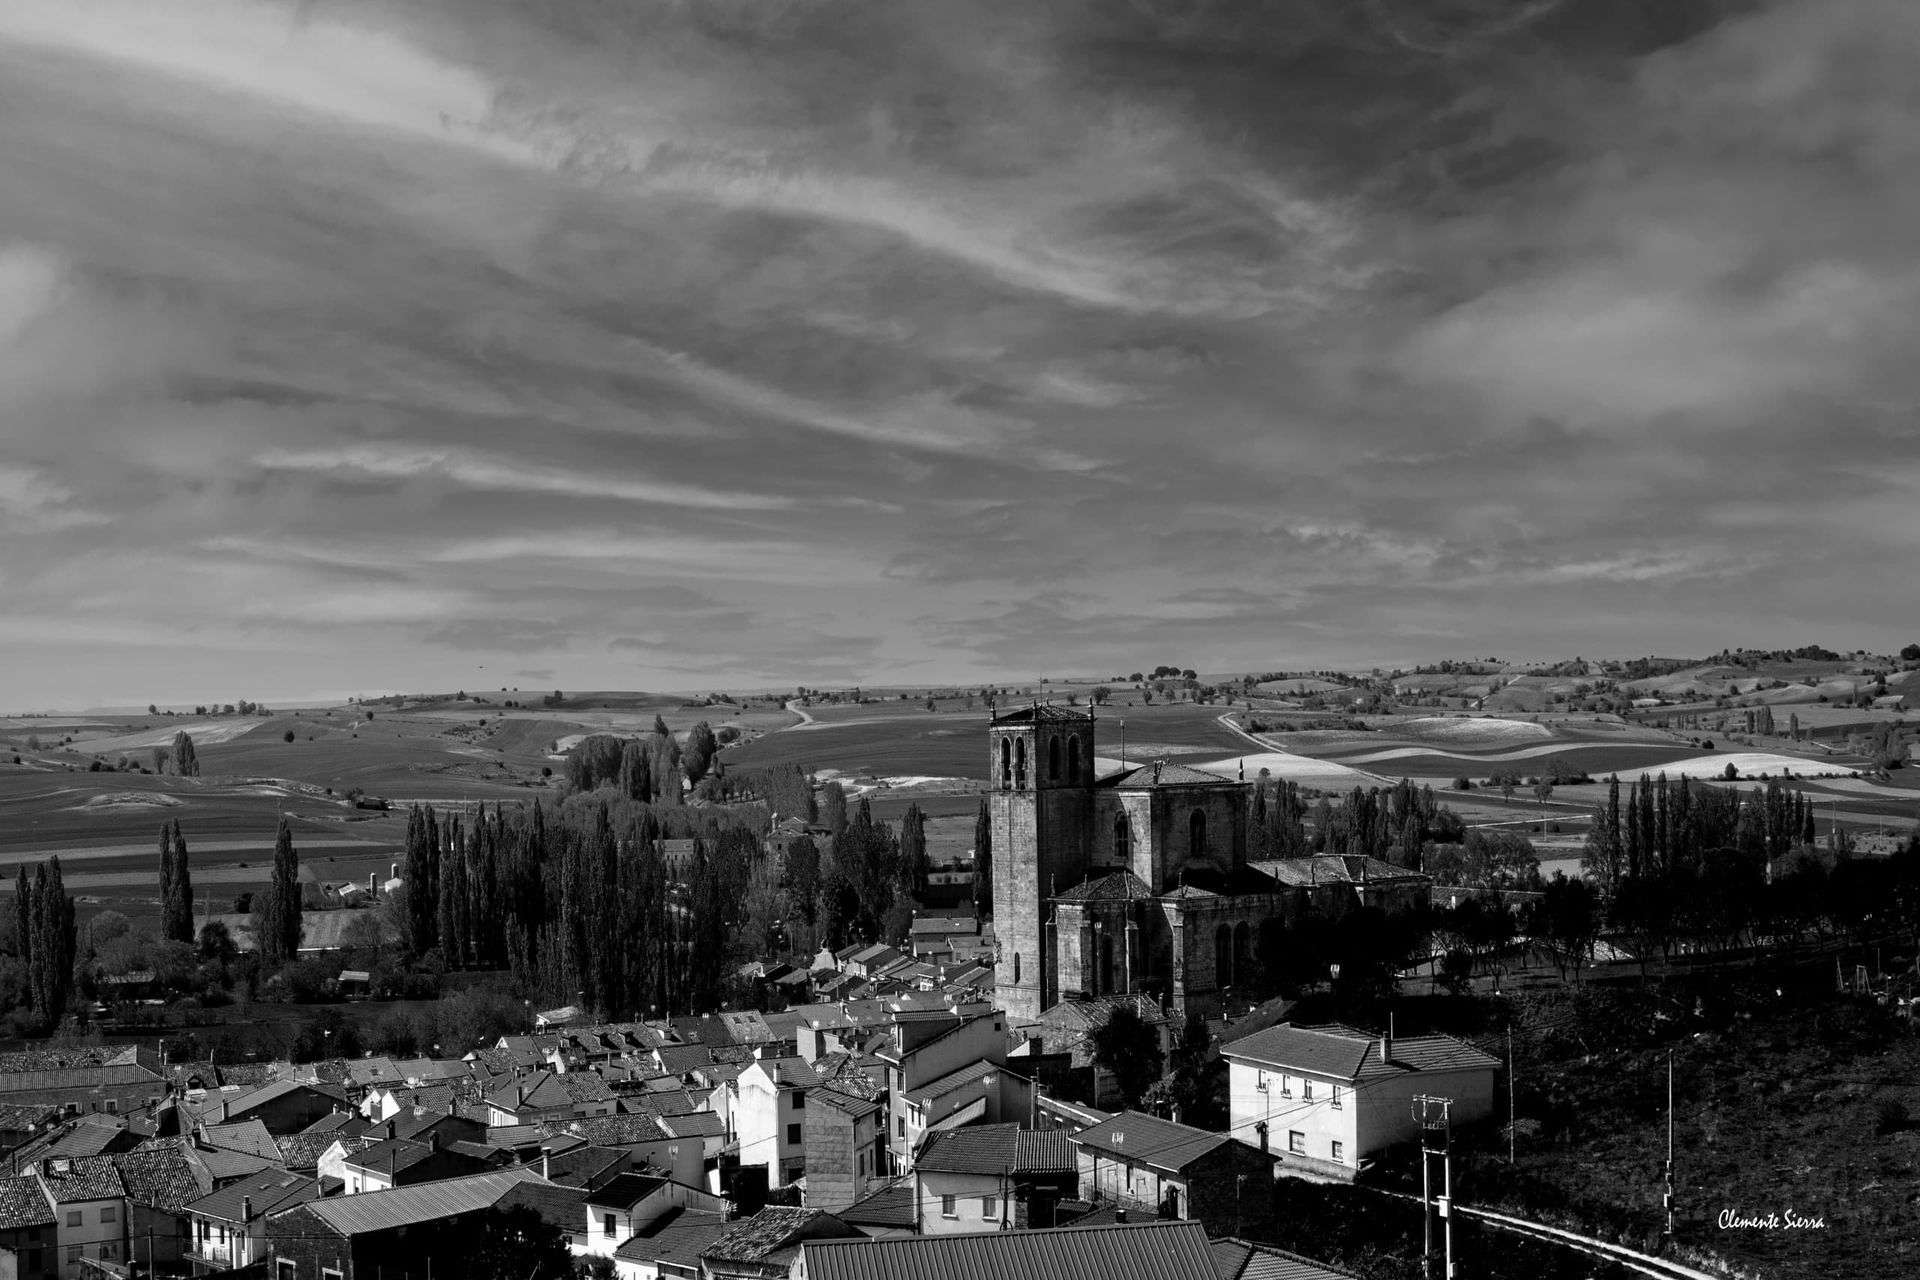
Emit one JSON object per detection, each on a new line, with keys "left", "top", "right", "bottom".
{"left": 987, "top": 704, "right": 1430, "bottom": 1019}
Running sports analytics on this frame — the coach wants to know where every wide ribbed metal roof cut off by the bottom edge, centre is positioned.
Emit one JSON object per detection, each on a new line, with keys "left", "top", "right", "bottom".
{"left": 803, "top": 1222, "right": 1217, "bottom": 1280}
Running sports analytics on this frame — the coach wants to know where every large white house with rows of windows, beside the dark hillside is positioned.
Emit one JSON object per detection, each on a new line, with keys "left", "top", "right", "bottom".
{"left": 1221, "top": 1023, "right": 1500, "bottom": 1180}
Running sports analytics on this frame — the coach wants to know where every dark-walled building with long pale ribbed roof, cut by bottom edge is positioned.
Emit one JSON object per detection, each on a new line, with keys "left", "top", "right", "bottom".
{"left": 267, "top": 1169, "right": 545, "bottom": 1280}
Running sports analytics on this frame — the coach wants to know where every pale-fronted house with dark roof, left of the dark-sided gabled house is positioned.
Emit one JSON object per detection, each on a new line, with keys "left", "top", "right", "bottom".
{"left": 912, "top": 1125, "right": 1079, "bottom": 1236}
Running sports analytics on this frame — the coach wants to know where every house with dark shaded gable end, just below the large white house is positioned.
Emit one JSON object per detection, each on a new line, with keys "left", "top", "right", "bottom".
{"left": 1068, "top": 1111, "right": 1275, "bottom": 1234}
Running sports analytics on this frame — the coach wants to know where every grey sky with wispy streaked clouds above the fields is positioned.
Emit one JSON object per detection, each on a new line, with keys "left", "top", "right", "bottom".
{"left": 0, "top": 0, "right": 1920, "bottom": 710}
